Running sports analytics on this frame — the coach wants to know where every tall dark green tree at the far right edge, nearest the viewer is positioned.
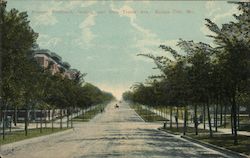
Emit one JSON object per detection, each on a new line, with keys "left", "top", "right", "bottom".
{"left": 206, "top": 2, "right": 250, "bottom": 144}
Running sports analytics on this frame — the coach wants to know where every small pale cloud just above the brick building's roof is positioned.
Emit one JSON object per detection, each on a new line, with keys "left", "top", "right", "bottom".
{"left": 37, "top": 34, "right": 62, "bottom": 48}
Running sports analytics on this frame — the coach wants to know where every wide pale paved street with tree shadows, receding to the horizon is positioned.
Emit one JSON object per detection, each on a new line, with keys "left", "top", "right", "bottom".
{"left": 0, "top": 103, "right": 229, "bottom": 158}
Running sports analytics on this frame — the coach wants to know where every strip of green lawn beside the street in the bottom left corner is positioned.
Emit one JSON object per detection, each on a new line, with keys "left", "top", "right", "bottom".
{"left": 0, "top": 128, "right": 69, "bottom": 145}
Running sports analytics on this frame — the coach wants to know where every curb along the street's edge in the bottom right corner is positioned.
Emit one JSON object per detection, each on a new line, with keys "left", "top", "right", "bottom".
{"left": 181, "top": 135, "right": 249, "bottom": 158}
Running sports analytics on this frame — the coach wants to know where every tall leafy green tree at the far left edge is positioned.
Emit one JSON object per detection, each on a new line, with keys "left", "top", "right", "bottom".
{"left": 0, "top": 1, "right": 38, "bottom": 138}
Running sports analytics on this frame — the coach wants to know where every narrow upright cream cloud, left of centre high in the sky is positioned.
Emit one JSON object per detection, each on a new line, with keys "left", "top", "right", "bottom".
{"left": 75, "top": 12, "right": 97, "bottom": 47}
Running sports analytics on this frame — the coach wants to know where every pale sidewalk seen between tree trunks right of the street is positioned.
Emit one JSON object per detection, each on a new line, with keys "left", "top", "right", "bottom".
{"left": 141, "top": 105, "right": 250, "bottom": 136}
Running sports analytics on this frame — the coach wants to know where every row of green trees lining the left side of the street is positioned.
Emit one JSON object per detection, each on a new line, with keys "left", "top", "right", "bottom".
{"left": 0, "top": 1, "right": 113, "bottom": 138}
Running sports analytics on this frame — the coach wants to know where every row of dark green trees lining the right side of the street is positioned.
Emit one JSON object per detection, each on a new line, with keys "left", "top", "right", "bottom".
{"left": 123, "top": 2, "right": 250, "bottom": 144}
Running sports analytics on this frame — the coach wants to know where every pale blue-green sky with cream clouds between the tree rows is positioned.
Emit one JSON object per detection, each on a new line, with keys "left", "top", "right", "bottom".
{"left": 7, "top": 0, "right": 238, "bottom": 99}
